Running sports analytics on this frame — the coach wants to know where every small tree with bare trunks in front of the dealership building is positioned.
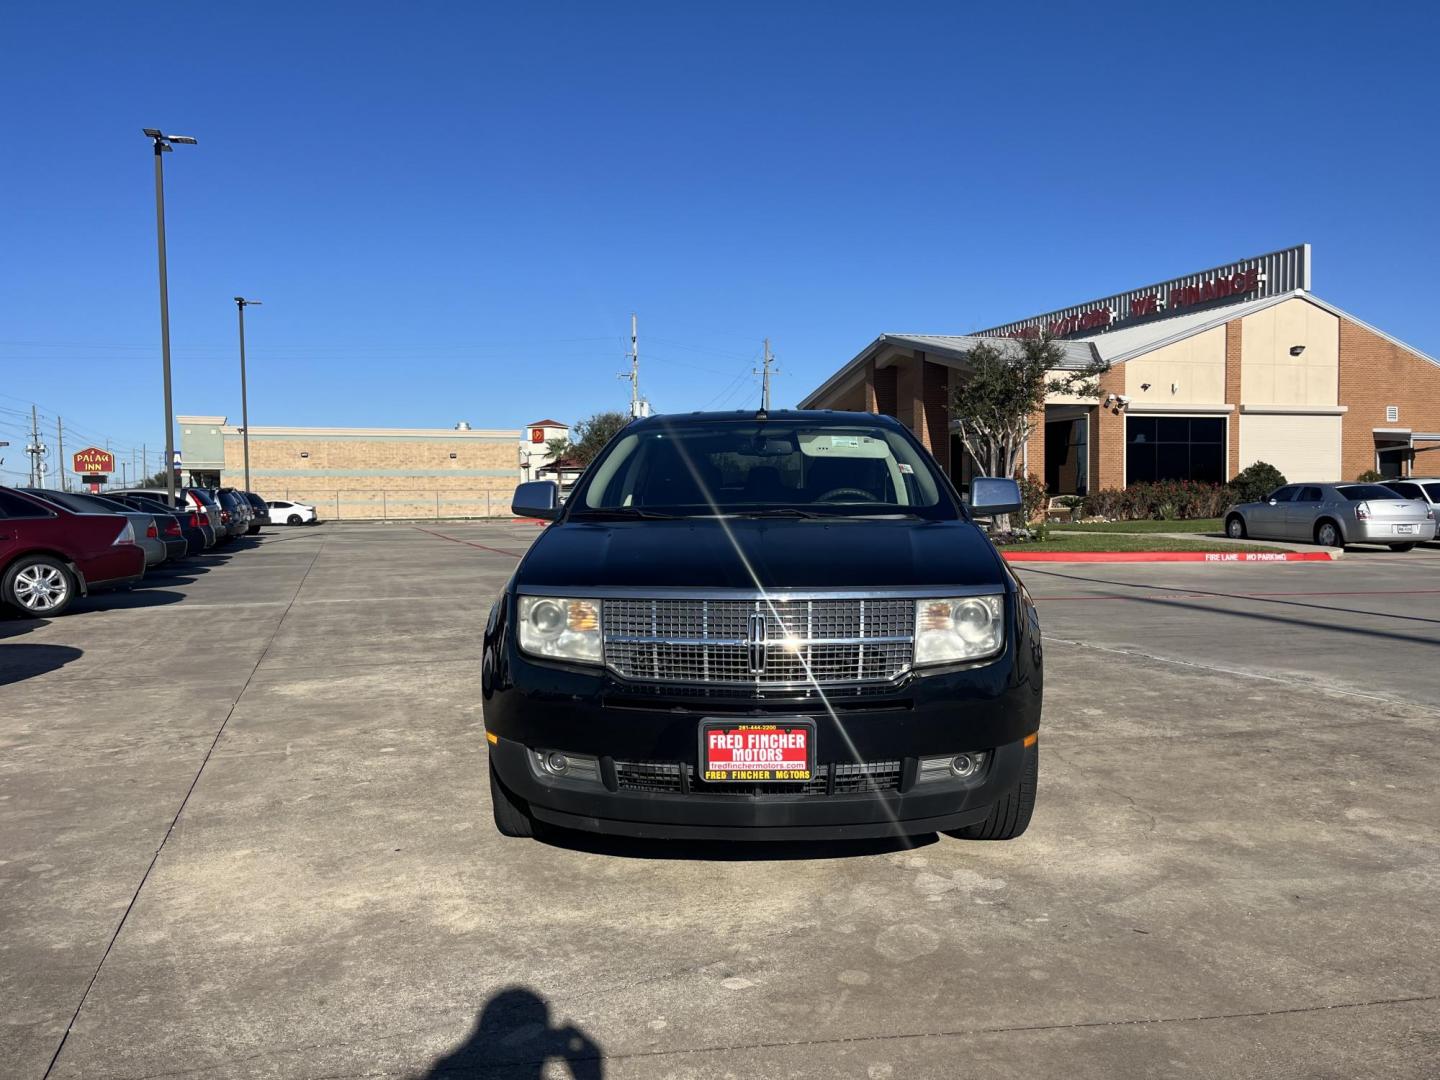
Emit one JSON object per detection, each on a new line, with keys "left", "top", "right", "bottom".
{"left": 950, "top": 334, "right": 1110, "bottom": 477}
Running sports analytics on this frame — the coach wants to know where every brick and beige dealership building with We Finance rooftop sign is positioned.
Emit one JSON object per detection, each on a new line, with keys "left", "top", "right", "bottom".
{"left": 801, "top": 245, "right": 1440, "bottom": 494}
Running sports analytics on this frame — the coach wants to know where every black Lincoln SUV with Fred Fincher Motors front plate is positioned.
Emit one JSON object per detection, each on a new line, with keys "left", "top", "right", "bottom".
{"left": 482, "top": 412, "right": 1043, "bottom": 840}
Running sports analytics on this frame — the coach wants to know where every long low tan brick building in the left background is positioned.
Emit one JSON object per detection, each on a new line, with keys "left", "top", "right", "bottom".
{"left": 176, "top": 416, "right": 569, "bottom": 520}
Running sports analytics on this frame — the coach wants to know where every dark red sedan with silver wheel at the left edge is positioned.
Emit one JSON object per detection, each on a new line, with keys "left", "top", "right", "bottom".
{"left": 0, "top": 487, "right": 145, "bottom": 618}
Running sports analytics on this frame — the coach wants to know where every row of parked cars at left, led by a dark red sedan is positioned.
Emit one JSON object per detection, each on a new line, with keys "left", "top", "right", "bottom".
{"left": 0, "top": 487, "right": 271, "bottom": 618}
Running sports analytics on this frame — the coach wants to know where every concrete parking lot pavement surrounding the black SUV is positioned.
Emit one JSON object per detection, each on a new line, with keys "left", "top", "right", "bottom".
{"left": 0, "top": 524, "right": 1440, "bottom": 1079}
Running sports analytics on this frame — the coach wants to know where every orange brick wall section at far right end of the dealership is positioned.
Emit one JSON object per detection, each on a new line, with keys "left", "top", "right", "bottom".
{"left": 1339, "top": 318, "right": 1440, "bottom": 480}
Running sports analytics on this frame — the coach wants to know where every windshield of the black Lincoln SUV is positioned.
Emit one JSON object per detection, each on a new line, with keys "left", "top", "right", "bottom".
{"left": 572, "top": 419, "right": 959, "bottom": 518}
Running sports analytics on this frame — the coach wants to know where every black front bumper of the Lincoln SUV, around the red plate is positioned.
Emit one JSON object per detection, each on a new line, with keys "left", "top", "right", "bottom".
{"left": 481, "top": 601, "right": 1043, "bottom": 840}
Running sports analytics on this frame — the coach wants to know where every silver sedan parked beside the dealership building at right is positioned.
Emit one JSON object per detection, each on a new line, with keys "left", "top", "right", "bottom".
{"left": 1225, "top": 484, "right": 1436, "bottom": 552}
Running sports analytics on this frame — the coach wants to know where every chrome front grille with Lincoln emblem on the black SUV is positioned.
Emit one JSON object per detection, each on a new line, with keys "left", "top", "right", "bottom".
{"left": 602, "top": 599, "right": 914, "bottom": 687}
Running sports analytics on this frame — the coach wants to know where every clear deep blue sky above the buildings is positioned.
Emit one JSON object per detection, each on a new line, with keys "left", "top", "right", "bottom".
{"left": 0, "top": 0, "right": 1440, "bottom": 481}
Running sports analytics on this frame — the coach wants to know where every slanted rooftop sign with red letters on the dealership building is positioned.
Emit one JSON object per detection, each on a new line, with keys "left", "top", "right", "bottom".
{"left": 976, "top": 243, "right": 1310, "bottom": 337}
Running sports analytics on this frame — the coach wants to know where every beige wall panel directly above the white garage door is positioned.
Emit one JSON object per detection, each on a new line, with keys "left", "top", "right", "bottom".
{"left": 1240, "top": 300, "right": 1341, "bottom": 405}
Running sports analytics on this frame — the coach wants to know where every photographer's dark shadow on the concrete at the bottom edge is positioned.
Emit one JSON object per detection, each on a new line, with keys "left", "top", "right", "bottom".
{"left": 423, "top": 986, "right": 605, "bottom": 1080}
